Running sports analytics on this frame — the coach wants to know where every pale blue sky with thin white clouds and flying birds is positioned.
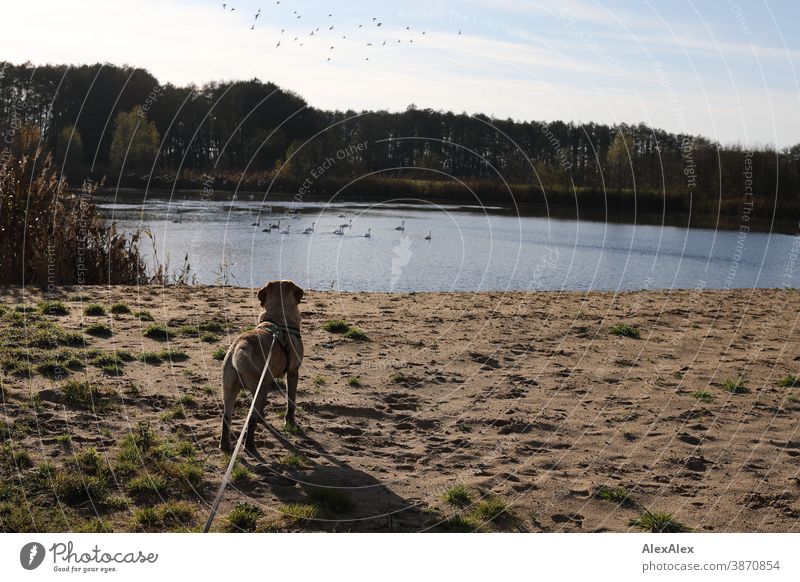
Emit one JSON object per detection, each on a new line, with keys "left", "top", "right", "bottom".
{"left": 0, "top": 0, "right": 800, "bottom": 148}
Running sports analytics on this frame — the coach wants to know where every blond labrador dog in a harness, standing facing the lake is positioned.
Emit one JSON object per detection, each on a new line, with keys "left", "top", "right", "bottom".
{"left": 219, "top": 281, "right": 303, "bottom": 456}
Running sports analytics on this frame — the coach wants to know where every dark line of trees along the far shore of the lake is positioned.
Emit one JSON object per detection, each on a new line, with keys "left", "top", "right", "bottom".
{"left": 0, "top": 63, "right": 800, "bottom": 218}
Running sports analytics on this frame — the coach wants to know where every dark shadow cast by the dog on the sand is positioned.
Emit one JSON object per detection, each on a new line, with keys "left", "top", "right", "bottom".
{"left": 240, "top": 423, "right": 443, "bottom": 532}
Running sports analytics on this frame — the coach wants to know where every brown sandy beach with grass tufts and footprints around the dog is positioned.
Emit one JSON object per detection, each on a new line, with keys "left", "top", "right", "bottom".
{"left": 0, "top": 287, "right": 800, "bottom": 532}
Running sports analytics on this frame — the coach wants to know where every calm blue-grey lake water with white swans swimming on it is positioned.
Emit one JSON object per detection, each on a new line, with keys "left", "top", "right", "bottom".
{"left": 99, "top": 195, "right": 800, "bottom": 291}
